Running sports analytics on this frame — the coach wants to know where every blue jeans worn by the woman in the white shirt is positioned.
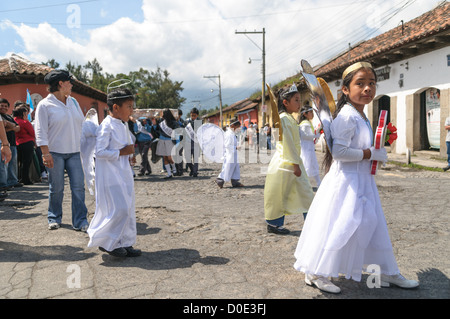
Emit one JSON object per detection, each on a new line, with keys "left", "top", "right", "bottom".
{"left": 47, "top": 152, "right": 88, "bottom": 229}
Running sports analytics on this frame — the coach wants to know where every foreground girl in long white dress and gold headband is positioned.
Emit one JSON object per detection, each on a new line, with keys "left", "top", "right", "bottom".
{"left": 294, "top": 62, "right": 418, "bottom": 293}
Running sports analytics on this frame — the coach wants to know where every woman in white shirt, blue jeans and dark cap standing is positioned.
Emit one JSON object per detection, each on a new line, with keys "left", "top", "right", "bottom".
{"left": 35, "top": 70, "right": 89, "bottom": 232}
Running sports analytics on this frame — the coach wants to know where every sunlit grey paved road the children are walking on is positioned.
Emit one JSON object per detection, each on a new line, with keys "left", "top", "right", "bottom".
{"left": 0, "top": 153, "right": 450, "bottom": 299}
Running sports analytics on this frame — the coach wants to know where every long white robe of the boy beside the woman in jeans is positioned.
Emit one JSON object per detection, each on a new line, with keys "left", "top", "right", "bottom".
{"left": 87, "top": 115, "right": 136, "bottom": 251}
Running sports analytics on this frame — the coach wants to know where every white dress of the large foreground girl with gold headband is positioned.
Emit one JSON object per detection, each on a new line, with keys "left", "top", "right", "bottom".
{"left": 294, "top": 105, "right": 399, "bottom": 281}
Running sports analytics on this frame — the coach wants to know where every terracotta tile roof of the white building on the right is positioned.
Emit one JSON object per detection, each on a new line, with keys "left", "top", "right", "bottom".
{"left": 315, "top": 1, "right": 450, "bottom": 79}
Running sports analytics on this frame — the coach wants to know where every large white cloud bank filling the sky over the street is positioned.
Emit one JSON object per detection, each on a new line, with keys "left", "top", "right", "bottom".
{"left": 0, "top": 0, "right": 442, "bottom": 105}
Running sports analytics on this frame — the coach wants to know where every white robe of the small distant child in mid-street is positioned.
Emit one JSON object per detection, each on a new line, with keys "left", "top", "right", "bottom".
{"left": 219, "top": 128, "right": 241, "bottom": 182}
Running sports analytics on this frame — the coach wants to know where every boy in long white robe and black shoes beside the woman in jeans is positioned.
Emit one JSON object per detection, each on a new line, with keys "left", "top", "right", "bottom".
{"left": 87, "top": 89, "right": 141, "bottom": 257}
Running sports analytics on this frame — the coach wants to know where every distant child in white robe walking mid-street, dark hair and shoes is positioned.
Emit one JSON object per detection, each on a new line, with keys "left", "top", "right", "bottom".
{"left": 216, "top": 118, "right": 244, "bottom": 188}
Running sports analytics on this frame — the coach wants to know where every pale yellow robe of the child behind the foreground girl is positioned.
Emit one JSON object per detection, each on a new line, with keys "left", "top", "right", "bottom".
{"left": 264, "top": 112, "right": 314, "bottom": 220}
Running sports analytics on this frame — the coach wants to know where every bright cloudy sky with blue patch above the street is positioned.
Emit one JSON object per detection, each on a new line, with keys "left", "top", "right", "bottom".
{"left": 0, "top": 0, "right": 439, "bottom": 112}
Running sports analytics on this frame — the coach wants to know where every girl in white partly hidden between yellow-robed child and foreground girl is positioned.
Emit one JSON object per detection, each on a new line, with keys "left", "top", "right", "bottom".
{"left": 299, "top": 104, "right": 320, "bottom": 187}
